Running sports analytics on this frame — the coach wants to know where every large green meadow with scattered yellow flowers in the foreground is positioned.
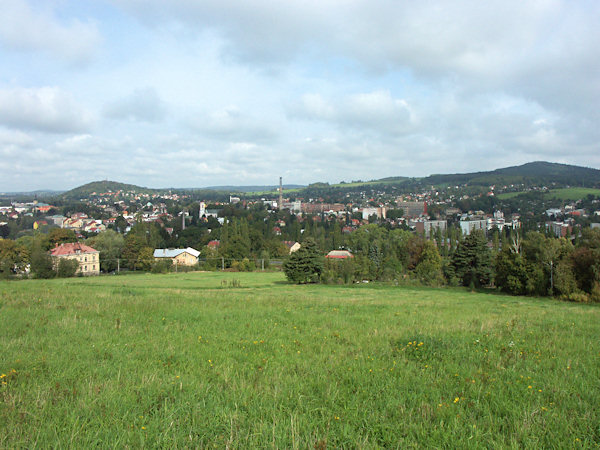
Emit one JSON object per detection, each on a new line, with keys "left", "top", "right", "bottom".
{"left": 0, "top": 272, "right": 600, "bottom": 448}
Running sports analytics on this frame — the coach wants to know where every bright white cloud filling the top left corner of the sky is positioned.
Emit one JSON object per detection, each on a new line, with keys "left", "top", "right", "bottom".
{"left": 0, "top": 0, "right": 101, "bottom": 63}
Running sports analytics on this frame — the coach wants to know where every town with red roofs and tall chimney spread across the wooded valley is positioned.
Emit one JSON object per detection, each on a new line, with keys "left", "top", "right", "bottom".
{"left": 0, "top": 162, "right": 600, "bottom": 302}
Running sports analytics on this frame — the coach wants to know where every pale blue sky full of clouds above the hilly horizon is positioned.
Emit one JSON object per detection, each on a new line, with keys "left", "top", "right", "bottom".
{"left": 0, "top": 0, "right": 600, "bottom": 192}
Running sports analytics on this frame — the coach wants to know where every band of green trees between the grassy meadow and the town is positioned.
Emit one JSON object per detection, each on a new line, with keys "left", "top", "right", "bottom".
{"left": 0, "top": 205, "right": 600, "bottom": 301}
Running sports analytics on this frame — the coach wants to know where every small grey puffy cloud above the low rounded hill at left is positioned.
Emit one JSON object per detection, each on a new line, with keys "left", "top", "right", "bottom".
{"left": 103, "top": 87, "right": 167, "bottom": 123}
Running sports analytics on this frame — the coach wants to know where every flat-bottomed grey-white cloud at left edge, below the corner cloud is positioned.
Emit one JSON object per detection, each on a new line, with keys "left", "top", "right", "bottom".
{"left": 0, "top": 87, "right": 92, "bottom": 133}
